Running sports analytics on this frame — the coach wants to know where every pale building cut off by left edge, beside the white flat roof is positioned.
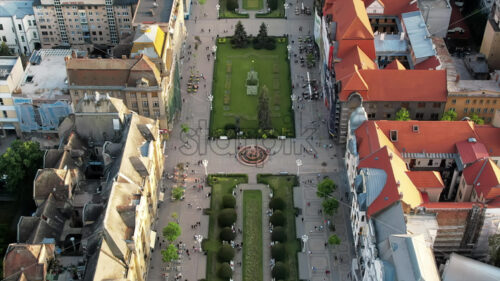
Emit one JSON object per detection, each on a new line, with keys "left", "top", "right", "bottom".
{"left": 0, "top": 57, "right": 24, "bottom": 136}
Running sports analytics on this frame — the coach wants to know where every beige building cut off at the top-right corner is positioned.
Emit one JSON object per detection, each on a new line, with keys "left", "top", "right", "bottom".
{"left": 480, "top": 0, "right": 500, "bottom": 69}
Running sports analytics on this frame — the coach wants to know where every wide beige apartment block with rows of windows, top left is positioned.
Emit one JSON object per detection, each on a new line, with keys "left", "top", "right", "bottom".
{"left": 33, "top": 0, "right": 137, "bottom": 52}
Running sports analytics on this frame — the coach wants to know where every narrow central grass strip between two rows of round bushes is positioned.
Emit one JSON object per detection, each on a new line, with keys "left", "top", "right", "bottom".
{"left": 242, "top": 190, "right": 263, "bottom": 281}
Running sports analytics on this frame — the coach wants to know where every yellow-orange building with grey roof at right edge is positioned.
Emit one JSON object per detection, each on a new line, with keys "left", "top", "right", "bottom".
{"left": 445, "top": 79, "right": 500, "bottom": 124}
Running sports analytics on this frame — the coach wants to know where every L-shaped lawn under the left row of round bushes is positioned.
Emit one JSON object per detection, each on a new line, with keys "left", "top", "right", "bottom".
{"left": 203, "top": 175, "right": 248, "bottom": 281}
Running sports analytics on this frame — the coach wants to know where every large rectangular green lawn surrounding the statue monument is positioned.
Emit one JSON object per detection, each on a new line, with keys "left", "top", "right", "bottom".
{"left": 210, "top": 38, "right": 295, "bottom": 138}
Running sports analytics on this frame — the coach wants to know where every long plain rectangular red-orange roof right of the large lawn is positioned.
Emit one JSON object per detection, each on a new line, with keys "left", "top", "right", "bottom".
{"left": 339, "top": 69, "right": 448, "bottom": 102}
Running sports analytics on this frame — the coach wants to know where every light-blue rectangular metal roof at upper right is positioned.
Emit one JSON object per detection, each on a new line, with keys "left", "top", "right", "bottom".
{"left": 401, "top": 11, "right": 436, "bottom": 59}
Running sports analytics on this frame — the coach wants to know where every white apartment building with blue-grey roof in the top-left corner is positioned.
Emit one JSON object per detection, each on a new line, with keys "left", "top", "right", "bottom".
{"left": 0, "top": 0, "right": 41, "bottom": 56}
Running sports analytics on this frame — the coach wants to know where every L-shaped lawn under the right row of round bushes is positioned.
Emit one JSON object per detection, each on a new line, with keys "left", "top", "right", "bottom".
{"left": 257, "top": 175, "right": 301, "bottom": 281}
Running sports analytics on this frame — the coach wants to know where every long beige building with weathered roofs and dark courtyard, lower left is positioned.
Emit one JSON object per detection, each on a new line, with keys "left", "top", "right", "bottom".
{"left": 4, "top": 95, "right": 163, "bottom": 281}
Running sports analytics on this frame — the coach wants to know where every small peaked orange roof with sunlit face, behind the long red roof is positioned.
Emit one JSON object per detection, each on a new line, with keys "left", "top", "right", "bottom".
{"left": 334, "top": 45, "right": 378, "bottom": 80}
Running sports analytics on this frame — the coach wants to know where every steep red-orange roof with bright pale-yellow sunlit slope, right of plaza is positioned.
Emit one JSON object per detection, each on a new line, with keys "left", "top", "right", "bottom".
{"left": 358, "top": 146, "right": 423, "bottom": 217}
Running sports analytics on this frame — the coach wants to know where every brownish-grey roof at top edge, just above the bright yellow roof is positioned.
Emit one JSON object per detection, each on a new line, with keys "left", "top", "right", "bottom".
{"left": 133, "top": 0, "right": 174, "bottom": 25}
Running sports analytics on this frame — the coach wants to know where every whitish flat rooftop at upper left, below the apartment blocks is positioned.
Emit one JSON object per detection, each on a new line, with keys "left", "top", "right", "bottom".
{"left": 19, "top": 49, "right": 72, "bottom": 99}
